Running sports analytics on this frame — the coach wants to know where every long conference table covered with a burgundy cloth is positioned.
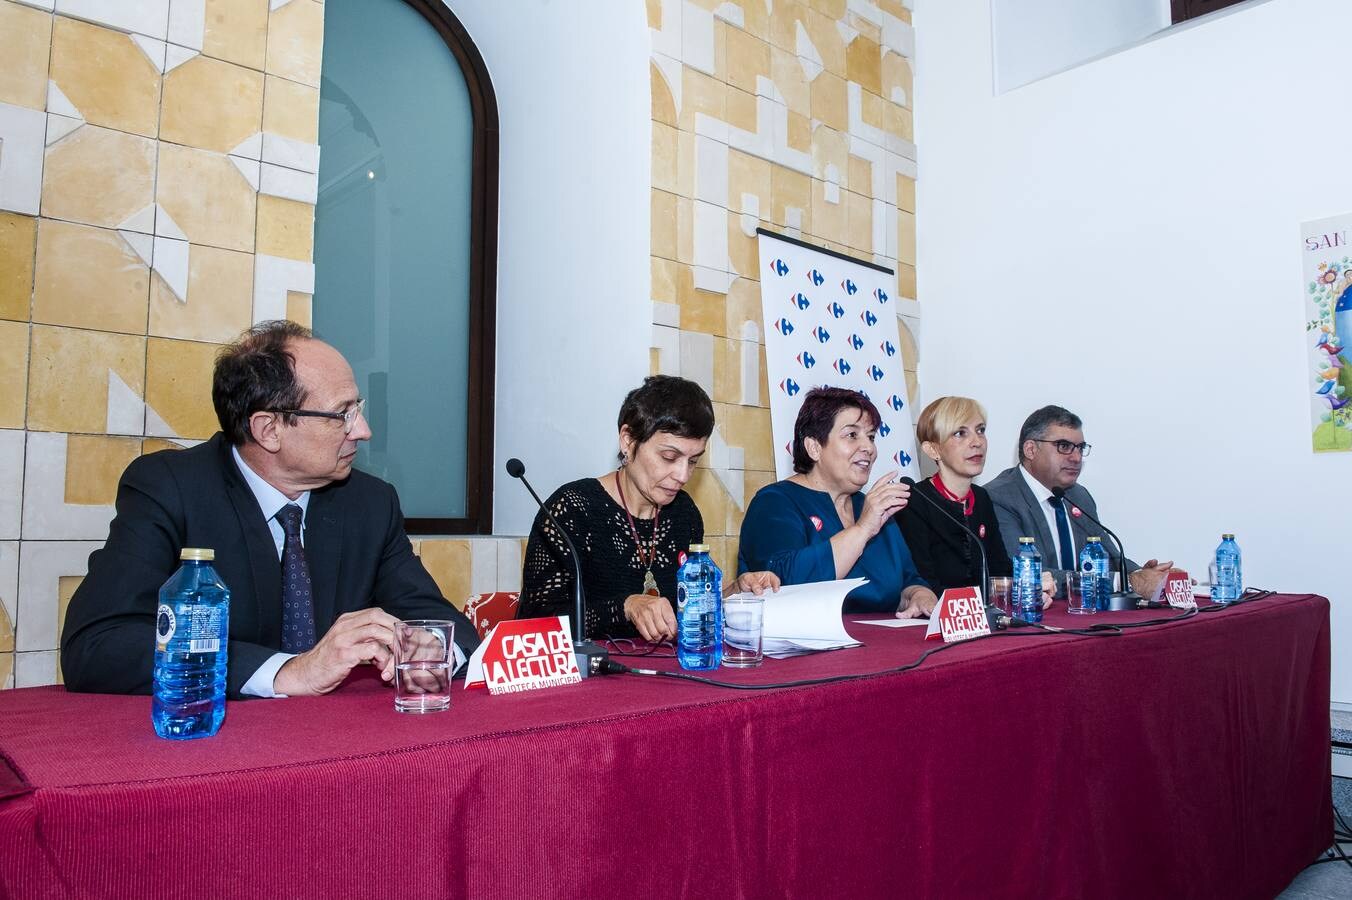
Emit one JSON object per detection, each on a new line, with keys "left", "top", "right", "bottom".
{"left": 0, "top": 595, "right": 1333, "bottom": 900}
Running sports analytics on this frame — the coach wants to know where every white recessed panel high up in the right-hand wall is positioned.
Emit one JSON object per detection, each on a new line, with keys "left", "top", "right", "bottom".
{"left": 991, "top": 0, "right": 1172, "bottom": 91}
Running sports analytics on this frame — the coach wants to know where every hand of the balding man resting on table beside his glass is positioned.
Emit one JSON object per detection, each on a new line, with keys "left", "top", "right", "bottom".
{"left": 272, "top": 607, "right": 397, "bottom": 697}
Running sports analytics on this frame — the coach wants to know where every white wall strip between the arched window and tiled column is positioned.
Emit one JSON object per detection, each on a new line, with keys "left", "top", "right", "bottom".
{"left": 448, "top": 0, "right": 653, "bottom": 534}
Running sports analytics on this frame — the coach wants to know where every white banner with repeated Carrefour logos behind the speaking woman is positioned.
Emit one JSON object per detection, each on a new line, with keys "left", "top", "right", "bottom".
{"left": 758, "top": 231, "right": 919, "bottom": 478}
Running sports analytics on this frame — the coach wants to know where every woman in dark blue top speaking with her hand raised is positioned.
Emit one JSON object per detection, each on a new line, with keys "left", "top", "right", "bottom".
{"left": 737, "top": 388, "right": 938, "bottom": 619}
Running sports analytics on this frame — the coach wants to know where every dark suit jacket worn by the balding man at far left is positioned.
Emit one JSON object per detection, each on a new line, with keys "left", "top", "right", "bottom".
{"left": 61, "top": 434, "right": 479, "bottom": 697}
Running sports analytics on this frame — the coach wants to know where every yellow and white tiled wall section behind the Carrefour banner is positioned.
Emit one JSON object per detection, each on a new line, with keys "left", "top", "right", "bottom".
{"left": 646, "top": 0, "right": 919, "bottom": 572}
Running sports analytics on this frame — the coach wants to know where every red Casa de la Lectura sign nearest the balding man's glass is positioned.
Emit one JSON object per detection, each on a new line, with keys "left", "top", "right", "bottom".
{"left": 465, "top": 616, "right": 583, "bottom": 693}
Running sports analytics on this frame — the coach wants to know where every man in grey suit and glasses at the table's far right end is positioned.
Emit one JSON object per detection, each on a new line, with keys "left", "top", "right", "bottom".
{"left": 986, "top": 407, "right": 1174, "bottom": 597}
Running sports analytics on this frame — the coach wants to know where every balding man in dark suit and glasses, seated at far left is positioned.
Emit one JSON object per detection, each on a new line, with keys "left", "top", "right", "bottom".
{"left": 61, "top": 322, "right": 479, "bottom": 697}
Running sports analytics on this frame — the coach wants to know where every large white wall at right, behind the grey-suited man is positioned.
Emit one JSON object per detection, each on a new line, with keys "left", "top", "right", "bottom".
{"left": 915, "top": 0, "right": 1352, "bottom": 703}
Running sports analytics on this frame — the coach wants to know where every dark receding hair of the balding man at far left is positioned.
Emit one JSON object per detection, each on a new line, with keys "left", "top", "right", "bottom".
{"left": 211, "top": 319, "right": 314, "bottom": 447}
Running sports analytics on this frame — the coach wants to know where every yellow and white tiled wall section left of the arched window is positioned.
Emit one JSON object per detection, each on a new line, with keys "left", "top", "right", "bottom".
{"left": 0, "top": 0, "right": 323, "bottom": 686}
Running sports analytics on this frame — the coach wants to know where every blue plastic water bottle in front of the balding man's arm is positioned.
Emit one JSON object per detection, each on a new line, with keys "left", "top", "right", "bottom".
{"left": 150, "top": 547, "right": 230, "bottom": 741}
